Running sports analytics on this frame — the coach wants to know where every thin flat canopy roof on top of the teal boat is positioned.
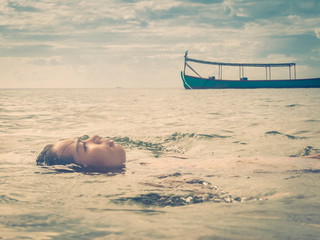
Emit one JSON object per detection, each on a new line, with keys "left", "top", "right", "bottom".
{"left": 185, "top": 54, "right": 296, "bottom": 67}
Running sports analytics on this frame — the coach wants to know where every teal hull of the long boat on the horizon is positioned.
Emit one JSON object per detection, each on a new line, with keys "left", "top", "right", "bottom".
{"left": 181, "top": 72, "right": 320, "bottom": 89}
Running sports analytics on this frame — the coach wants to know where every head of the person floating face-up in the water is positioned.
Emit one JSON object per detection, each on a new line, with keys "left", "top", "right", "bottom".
{"left": 37, "top": 135, "right": 126, "bottom": 168}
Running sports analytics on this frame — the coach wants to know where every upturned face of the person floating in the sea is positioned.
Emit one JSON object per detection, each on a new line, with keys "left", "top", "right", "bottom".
{"left": 52, "top": 135, "right": 126, "bottom": 167}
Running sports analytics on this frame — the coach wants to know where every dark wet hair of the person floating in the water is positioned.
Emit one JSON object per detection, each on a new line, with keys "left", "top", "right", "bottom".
{"left": 36, "top": 144, "right": 75, "bottom": 165}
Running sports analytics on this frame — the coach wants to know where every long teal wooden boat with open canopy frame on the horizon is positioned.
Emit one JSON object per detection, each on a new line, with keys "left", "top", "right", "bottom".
{"left": 181, "top": 51, "right": 320, "bottom": 89}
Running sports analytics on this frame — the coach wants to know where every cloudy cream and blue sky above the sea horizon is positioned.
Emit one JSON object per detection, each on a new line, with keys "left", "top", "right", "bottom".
{"left": 0, "top": 0, "right": 320, "bottom": 88}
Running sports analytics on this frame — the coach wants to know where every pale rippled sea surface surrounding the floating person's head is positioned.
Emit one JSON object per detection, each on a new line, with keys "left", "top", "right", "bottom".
{"left": 0, "top": 88, "right": 320, "bottom": 240}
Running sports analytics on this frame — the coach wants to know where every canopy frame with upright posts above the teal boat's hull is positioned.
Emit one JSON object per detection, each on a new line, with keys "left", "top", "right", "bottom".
{"left": 184, "top": 51, "right": 297, "bottom": 80}
